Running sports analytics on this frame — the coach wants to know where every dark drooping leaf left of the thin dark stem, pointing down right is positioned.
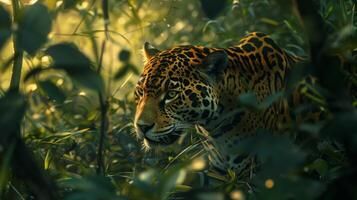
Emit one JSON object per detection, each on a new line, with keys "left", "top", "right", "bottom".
{"left": 46, "top": 43, "right": 103, "bottom": 90}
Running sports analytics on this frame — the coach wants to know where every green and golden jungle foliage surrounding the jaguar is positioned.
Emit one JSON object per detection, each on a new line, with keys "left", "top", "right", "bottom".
{"left": 0, "top": 0, "right": 357, "bottom": 200}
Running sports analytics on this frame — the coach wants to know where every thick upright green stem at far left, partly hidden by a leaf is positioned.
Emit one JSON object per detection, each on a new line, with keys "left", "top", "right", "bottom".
{"left": 10, "top": 0, "right": 23, "bottom": 91}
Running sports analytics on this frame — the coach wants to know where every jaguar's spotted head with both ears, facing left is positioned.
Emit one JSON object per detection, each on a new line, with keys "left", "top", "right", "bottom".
{"left": 134, "top": 43, "right": 228, "bottom": 146}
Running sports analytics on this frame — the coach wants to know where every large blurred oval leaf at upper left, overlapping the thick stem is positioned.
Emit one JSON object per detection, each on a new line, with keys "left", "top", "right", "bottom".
{"left": 16, "top": 3, "right": 52, "bottom": 55}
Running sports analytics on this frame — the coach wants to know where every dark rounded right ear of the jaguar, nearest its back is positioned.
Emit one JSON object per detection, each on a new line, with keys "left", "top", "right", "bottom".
{"left": 202, "top": 51, "right": 228, "bottom": 77}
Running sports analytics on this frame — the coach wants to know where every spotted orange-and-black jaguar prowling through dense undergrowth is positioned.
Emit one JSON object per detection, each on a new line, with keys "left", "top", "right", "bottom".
{"left": 134, "top": 32, "right": 302, "bottom": 177}
